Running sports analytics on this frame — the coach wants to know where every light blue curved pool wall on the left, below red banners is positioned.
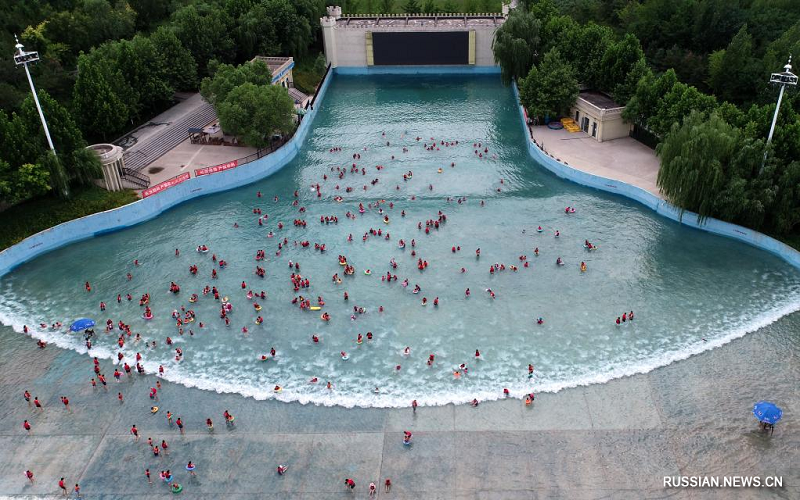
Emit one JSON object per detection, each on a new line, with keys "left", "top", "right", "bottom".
{"left": 0, "top": 66, "right": 332, "bottom": 276}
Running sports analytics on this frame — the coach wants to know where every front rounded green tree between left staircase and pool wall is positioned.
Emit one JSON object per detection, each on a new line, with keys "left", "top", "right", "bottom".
{"left": 217, "top": 82, "right": 294, "bottom": 148}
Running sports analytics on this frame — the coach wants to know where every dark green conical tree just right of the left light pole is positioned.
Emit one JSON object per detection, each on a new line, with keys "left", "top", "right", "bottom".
{"left": 72, "top": 55, "right": 129, "bottom": 140}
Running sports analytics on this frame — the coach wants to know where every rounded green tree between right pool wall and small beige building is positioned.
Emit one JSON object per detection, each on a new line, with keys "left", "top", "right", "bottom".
{"left": 520, "top": 49, "right": 579, "bottom": 117}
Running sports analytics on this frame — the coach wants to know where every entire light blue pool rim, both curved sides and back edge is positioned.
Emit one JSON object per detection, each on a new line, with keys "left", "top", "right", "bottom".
{"left": 0, "top": 66, "right": 800, "bottom": 278}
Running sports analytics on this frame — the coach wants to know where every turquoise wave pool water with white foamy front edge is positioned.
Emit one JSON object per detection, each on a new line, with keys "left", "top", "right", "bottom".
{"left": 0, "top": 76, "right": 800, "bottom": 407}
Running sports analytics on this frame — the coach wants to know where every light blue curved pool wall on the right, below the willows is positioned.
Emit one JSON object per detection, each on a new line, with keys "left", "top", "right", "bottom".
{"left": 513, "top": 83, "right": 800, "bottom": 269}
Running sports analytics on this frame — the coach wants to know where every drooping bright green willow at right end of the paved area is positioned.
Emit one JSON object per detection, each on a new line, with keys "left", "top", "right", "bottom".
{"left": 656, "top": 111, "right": 739, "bottom": 220}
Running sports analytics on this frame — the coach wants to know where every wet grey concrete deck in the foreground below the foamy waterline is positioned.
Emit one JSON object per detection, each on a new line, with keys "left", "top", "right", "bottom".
{"left": 0, "top": 314, "right": 800, "bottom": 500}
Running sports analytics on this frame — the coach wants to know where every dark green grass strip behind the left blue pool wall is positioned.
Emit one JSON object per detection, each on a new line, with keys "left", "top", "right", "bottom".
{"left": 0, "top": 186, "right": 137, "bottom": 250}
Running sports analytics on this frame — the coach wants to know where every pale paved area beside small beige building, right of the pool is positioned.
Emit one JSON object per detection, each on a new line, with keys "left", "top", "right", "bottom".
{"left": 531, "top": 126, "right": 664, "bottom": 198}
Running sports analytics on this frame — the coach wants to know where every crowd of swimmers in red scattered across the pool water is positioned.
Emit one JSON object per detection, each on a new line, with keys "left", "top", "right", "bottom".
{"left": 20, "top": 129, "right": 633, "bottom": 426}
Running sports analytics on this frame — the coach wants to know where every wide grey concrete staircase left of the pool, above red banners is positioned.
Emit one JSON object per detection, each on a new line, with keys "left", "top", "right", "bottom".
{"left": 123, "top": 102, "right": 217, "bottom": 172}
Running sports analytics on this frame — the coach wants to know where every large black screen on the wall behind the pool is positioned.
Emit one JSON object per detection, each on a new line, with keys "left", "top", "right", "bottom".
{"left": 372, "top": 31, "right": 469, "bottom": 66}
